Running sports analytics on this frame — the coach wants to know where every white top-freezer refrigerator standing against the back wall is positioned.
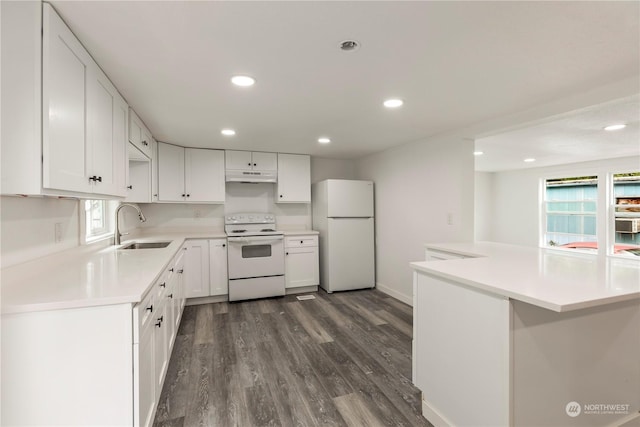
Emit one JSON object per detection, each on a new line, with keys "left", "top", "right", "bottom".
{"left": 311, "top": 179, "right": 375, "bottom": 293}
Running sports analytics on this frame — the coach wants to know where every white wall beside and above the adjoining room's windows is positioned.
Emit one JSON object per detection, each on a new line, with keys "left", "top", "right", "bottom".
{"left": 478, "top": 156, "right": 640, "bottom": 246}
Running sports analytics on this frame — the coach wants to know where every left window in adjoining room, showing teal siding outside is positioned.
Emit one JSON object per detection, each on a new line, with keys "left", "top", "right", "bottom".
{"left": 544, "top": 176, "right": 598, "bottom": 250}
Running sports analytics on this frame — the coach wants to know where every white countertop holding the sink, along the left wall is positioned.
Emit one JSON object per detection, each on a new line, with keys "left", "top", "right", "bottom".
{"left": 1, "top": 229, "right": 226, "bottom": 314}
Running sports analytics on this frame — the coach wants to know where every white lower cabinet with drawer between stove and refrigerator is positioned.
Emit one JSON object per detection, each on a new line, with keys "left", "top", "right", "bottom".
{"left": 284, "top": 235, "right": 320, "bottom": 289}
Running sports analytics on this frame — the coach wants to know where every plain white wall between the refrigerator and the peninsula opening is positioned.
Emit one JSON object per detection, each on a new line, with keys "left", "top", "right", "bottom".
{"left": 356, "top": 136, "right": 474, "bottom": 303}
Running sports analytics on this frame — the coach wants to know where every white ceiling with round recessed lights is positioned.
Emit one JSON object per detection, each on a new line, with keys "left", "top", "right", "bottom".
{"left": 51, "top": 0, "right": 640, "bottom": 168}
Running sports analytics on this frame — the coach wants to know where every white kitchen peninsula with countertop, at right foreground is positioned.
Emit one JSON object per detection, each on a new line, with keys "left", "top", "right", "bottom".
{"left": 411, "top": 242, "right": 640, "bottom": 426}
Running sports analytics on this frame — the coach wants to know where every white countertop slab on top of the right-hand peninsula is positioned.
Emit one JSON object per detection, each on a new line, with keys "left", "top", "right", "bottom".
{"left": 411, "top": 242, "right": 640, "bottom": 312}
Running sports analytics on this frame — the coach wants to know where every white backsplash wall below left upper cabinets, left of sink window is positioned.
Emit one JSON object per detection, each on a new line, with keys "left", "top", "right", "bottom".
{"left": 0, "top": 196, "right": 80, "bottom": 268}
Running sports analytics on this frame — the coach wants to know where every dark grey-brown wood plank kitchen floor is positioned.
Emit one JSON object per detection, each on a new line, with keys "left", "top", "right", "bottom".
{"left": 155, "top": 290, "right": 430, "bottom": 427}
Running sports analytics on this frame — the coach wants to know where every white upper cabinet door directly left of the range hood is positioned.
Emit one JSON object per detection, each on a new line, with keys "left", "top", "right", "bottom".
{"left": 185, "top": 148, "right": 225, "bottom": 203}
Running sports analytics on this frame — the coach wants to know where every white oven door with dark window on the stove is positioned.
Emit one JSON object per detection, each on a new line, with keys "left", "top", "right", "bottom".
{"left": 227, "top": 236, "right": 284, "bottom": 279}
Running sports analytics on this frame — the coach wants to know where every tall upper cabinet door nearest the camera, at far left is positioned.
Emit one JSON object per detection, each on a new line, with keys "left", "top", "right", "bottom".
{"left": 42, "top": 3, "right": 93, "bottom": 193}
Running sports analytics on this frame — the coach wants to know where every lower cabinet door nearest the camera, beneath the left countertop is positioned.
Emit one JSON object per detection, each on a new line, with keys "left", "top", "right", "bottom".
{"left": 133, "top": 325, "right": 159, "bottom": 427}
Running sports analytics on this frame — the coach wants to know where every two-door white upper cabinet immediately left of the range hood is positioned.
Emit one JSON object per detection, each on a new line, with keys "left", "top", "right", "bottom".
{"left": 158, "top": 142, "right": 225, "bottom": 203}
